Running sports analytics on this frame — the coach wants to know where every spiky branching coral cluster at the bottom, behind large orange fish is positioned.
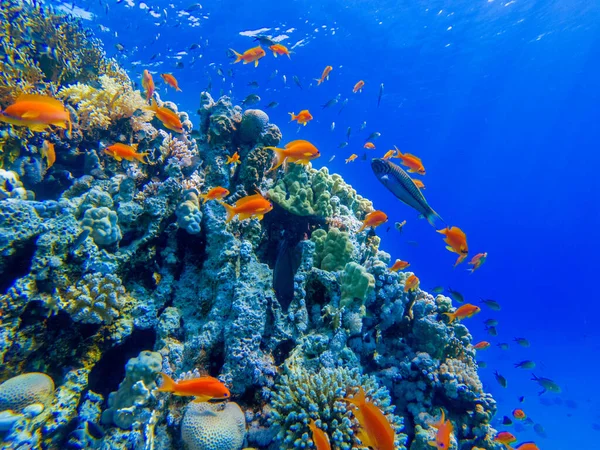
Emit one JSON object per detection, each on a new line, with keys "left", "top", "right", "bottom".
{"left": 269, "top": 365, "right": 405, "bottom": 450}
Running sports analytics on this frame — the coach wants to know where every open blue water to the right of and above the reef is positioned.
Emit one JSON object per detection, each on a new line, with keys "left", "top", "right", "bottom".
{"left": 52, "top": 0, "right": 600, "bottom": 450}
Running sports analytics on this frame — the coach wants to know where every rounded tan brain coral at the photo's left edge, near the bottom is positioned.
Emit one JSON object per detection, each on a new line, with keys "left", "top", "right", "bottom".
{"left": 0, "top": 372, "right": 54, "bottom": 413}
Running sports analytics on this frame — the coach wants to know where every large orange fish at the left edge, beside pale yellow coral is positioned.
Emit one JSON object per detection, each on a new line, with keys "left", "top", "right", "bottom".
{"left": 0, "top": 94, "right": 72, "bottom": 133}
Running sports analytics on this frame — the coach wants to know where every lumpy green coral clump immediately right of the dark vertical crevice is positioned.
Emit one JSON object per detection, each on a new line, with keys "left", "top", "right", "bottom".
{"left": 311, "top": 228, "right": 354, "bottom": 272}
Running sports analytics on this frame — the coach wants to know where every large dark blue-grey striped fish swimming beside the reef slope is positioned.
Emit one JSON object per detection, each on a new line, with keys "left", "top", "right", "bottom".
{"left": 371, "top": 158, "right": 444, "bottom": 227}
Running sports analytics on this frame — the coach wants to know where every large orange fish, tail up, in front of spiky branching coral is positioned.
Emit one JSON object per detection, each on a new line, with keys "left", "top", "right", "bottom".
{"left": 343, "top": 387, "right": 396, "bottom": 450}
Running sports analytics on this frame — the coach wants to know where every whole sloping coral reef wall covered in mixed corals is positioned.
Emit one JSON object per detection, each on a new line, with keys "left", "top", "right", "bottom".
{"left": 0, "top": 1, "right": 500, "bottom": 450}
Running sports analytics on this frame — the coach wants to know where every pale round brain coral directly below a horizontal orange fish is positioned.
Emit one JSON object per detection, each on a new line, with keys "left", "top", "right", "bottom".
{"left": 181, "top": 402, "right": 246, "bottom": 450}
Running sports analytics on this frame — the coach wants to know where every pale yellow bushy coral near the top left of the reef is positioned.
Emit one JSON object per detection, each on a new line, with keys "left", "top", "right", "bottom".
{"left": 58, "top": 75, "right": 156, "bottom": 134}
